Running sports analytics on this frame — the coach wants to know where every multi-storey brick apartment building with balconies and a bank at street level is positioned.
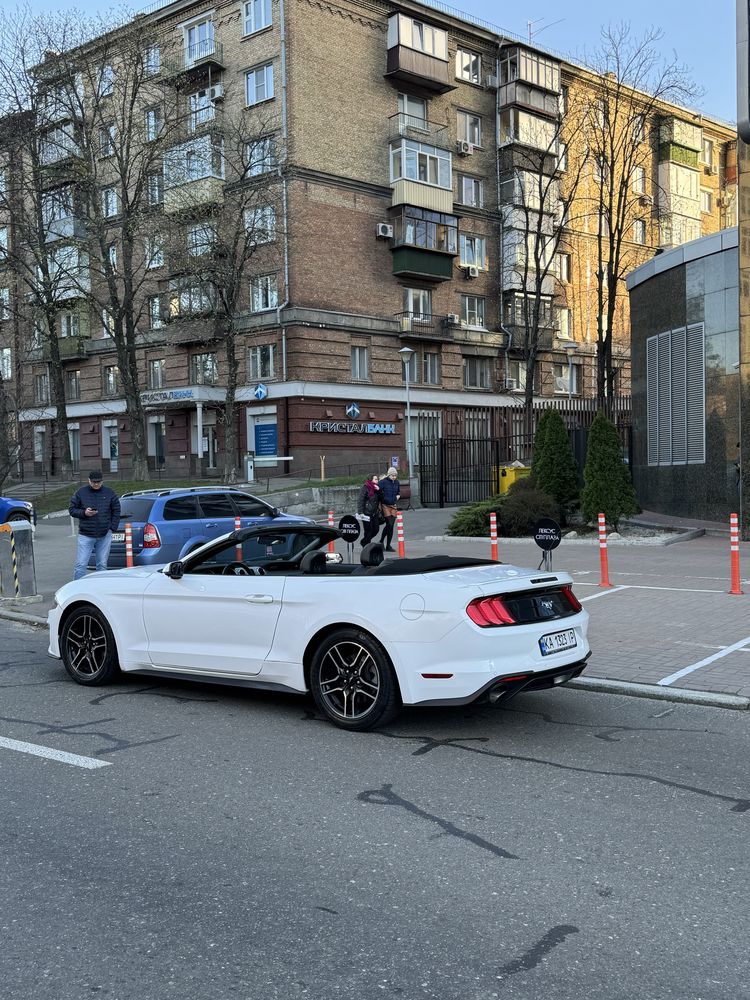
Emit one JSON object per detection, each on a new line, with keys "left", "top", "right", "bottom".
{"left": 0, "top": 0, "right": 736, "bottom": 475}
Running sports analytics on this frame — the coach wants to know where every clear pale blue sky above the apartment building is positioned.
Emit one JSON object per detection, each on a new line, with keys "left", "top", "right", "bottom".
{"left": 30, "top": 0, "right": 736, "bottom": 121}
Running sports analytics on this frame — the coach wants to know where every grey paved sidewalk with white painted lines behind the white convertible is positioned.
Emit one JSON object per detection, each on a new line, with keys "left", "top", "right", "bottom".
{"left": 5, "top": 509, "right": 750, "bottom": 707}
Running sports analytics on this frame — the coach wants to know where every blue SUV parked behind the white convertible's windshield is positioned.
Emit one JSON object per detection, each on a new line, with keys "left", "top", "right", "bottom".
{"left": 108, "top": 486, "right": 310, "bottom": 569}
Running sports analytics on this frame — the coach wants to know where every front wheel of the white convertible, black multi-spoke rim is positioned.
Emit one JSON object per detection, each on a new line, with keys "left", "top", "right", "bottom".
{"left": 60, "top": 604, "right": 120, "bottom": 687}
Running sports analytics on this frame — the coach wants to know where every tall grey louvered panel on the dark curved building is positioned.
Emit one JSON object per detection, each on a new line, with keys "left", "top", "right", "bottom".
{"left": 646, "top": 323, "right": 706, "bottom": 465}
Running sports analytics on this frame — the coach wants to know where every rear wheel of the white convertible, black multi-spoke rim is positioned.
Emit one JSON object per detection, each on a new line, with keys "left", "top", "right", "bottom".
{"left": 310, "top": 627, "right": 401, "bottom": 732}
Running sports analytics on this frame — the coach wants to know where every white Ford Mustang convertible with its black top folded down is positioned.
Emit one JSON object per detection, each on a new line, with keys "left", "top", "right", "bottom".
{"left": 49, "top": 524, "right": 589, "bottom": 730}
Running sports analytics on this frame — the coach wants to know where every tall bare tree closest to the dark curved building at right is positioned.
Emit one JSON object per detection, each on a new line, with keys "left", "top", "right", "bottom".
{"left": 586, "top": 24, "right": 698, "bottom": 402}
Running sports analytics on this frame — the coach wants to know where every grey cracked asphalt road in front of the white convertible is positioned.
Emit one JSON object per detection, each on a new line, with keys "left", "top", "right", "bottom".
{"left": 0, "top": 621, "right": 750, "bottom": 1000}
